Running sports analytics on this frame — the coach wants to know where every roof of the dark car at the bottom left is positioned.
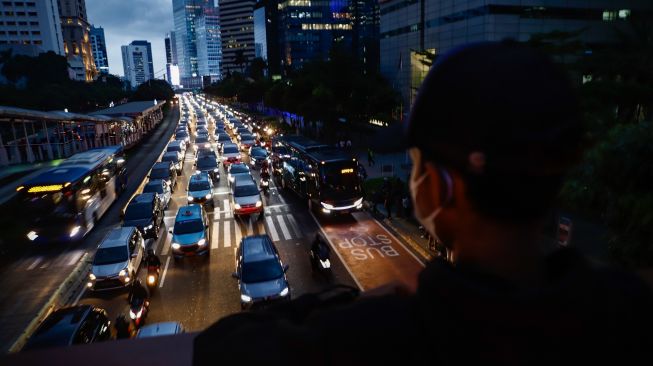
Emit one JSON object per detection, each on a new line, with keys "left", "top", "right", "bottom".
{"left": 25, "top": 305, "right": 93, "bottom": 349}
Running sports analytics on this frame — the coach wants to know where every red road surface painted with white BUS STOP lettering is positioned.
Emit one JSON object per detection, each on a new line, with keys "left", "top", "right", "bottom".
{"left": 322, "top": 213, "right": 424, "bottom": 290}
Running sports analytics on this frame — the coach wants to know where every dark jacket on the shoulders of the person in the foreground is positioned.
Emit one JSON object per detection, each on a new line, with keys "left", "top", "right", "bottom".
{"left": 193, "top": 249, "right": 653, "bottom": 365}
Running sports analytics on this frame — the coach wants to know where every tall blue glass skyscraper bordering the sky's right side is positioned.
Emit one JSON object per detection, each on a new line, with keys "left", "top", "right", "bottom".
{"left": 171, "top": 0, "right": 214, "bottom": 78}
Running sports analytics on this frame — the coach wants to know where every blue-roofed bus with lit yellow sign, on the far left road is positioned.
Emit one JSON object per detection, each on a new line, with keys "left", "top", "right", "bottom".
{"left": 16, "top": 146, "right": 127, "bottom": 243}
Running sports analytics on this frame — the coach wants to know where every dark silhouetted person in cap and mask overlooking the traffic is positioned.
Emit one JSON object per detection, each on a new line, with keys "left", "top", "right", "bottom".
{"left": 194, "top": 43, "right": 653, "bottom": 365}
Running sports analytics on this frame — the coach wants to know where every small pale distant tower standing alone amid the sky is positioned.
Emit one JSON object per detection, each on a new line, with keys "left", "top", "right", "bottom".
{"left": 121, "top": 41, "right": 154, "bottom": 88}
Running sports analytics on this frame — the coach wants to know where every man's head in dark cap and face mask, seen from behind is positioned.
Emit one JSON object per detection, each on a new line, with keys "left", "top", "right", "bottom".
{"left": 406, "top": 42, "right": 581, "bottom": 249}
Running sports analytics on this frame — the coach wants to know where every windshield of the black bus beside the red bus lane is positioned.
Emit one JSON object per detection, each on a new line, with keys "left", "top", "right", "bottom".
{"left": 320, "top": 161, "right": 361, "bottom": 199}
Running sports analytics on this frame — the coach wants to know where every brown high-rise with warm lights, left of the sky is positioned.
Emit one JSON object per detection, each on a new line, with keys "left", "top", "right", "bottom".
{"left": 58, "top": 0, "right": 98, "bottom": 81}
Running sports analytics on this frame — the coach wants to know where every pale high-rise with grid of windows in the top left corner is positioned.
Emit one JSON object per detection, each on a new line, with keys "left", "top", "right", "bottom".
{"left": 0, "top": 0, "right": 65, "bottom": 56}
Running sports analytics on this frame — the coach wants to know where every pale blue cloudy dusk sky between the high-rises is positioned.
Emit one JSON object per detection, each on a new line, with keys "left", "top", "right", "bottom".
{"left": 86, "top": 0, "right": 173, "bottom": 78}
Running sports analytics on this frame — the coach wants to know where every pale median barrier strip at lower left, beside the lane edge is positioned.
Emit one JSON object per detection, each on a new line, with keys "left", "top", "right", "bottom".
{"left": 9, "top": 252, "right": 91, "bottom": 353}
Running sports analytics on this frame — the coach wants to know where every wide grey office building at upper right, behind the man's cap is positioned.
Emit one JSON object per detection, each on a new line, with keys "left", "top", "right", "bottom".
{"left": 380, "top": 0, "right": 653, "bottom": 115}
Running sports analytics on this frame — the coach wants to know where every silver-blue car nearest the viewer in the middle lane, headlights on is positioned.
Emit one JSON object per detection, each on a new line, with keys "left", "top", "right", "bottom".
{"left": 232, "top": 235, "right": 290, "bottom": 309}
